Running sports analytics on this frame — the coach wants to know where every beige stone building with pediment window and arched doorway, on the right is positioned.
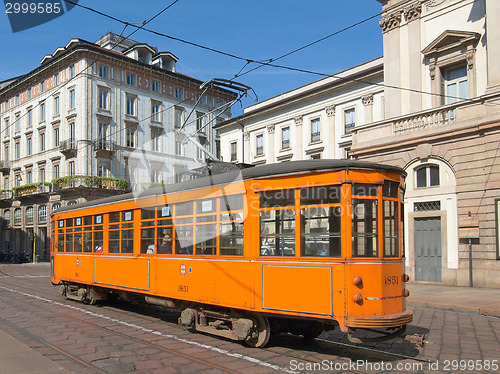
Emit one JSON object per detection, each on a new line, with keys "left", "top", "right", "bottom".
{"left": 219, "top": 0, "right": 500, "bottom": 287}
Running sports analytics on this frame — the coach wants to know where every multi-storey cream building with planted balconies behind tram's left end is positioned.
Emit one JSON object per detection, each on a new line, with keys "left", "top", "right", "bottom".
{"left": 0, "top": 33, "right": 235, "bottom": 259}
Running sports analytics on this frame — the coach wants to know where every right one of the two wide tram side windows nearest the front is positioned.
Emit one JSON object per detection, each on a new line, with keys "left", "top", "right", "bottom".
{"left": 300, "top": 207, "right": 341, "bottom": 257}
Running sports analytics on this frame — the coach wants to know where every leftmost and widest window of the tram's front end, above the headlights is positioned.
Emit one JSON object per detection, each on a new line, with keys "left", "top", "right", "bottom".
{"left": 352, "top": 199, "right": 378, "bottom": 257}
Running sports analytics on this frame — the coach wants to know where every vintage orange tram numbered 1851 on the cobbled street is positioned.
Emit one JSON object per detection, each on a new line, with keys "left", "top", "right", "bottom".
{"left": 51, "top": 160, "right": 412, "bottom": 347}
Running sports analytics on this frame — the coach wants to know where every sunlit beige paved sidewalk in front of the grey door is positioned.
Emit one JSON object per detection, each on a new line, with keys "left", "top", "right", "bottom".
{"left": 407, "top": 283, "right": 500, "bottom": 317}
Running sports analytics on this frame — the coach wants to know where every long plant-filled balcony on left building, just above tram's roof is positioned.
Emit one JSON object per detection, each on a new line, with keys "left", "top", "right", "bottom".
{"left": 52, "top": 175, "right": 128, "bottom": 191}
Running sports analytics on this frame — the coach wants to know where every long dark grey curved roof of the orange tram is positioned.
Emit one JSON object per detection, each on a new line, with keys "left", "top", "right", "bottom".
{"left": 52, "top": 159, "right": 406, "bottom": 215}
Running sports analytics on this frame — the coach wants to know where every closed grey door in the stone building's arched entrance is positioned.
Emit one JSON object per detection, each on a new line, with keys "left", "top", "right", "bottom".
{"left": 415, "top": 217, "right": 441, "bottom": 282}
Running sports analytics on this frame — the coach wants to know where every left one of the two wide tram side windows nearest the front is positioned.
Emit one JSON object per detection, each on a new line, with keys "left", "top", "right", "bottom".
{"left": 260, "top": 209, "right": 295, "bottom": 256}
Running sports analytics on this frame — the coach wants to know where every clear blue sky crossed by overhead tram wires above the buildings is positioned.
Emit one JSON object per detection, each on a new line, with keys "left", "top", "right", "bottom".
{"left": 0, "top": 0, "right": 382, "bottom": 106}
